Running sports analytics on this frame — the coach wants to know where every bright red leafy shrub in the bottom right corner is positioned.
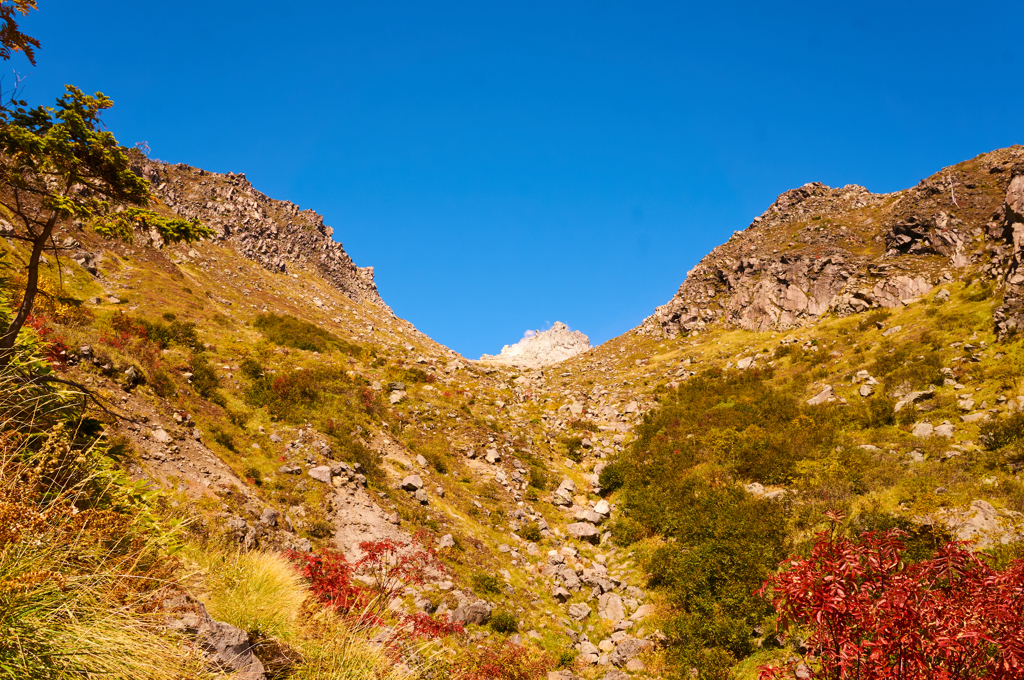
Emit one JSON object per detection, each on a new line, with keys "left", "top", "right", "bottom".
{"left": 760, "top": 515, "right": 1024, "bottom": 680}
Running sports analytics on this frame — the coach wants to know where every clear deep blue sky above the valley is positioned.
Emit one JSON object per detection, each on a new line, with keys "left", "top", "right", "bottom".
{"left": 18, "top": 0, "right": 1024, "bottom": 357}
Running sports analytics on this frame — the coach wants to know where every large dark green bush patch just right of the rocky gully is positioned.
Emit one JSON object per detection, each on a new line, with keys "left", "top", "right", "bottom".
{"left": 599, "top": 368, "right": 913, "bottom": 677}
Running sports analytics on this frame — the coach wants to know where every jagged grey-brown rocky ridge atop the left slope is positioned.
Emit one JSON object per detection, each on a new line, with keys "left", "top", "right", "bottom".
{"left": 128, "top": 156, "right": 387, "bottom": 307}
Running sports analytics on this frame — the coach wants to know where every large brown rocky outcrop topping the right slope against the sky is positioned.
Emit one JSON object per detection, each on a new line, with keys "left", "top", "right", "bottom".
{"left": 641, "top": 146, "right": 1024, "bottom": 336}
